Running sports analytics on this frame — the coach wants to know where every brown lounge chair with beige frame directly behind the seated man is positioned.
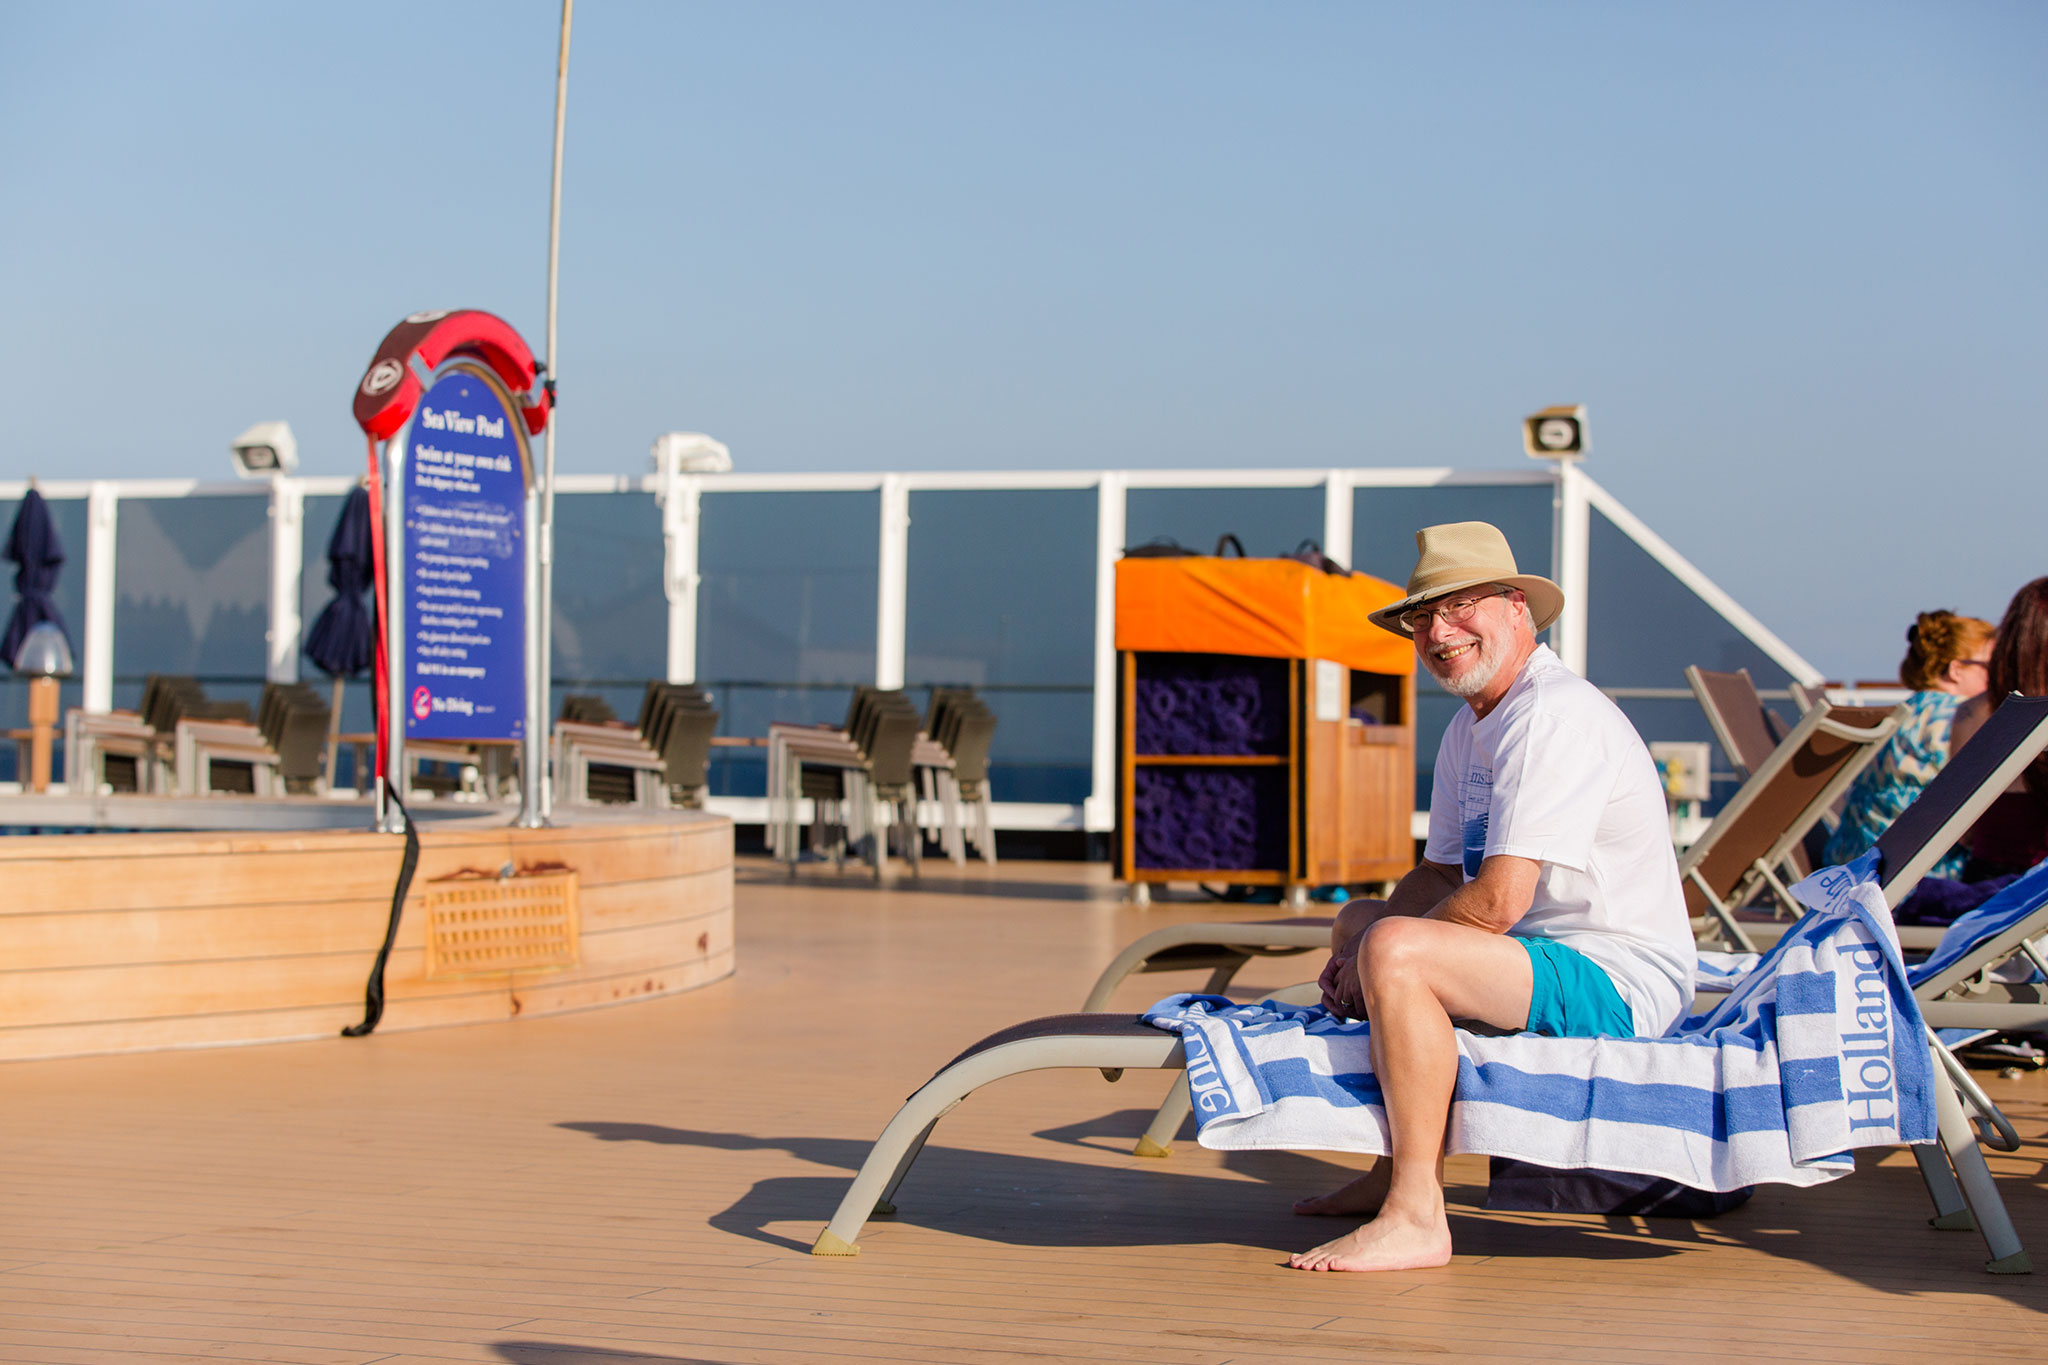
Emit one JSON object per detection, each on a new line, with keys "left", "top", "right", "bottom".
{"left": 1081, "top": 702, "right": 1900, "bottom": 1011}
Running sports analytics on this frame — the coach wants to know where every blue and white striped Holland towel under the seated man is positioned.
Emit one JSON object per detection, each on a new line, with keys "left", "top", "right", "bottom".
{"left": 1145, "top": 855, "right": 1935, "bottom": 1191}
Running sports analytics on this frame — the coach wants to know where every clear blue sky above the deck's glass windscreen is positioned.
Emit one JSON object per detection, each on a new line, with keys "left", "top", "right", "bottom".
{"left": 0, "top": 0, "right": 2048, "bottom": 675}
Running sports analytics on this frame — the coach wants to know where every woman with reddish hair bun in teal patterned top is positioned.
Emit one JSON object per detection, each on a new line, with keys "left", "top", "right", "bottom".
{"left": 1827, "top": 609, "right": 1990, "bottom": 878}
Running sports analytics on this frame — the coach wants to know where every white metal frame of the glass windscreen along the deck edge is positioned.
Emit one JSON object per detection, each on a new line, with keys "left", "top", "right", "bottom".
{"left": 0, "top": 465, "right": 1821, "bottom": 831}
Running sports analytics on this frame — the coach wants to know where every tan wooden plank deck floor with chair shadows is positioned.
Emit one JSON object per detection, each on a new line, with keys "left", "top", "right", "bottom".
{"left": 0, "top": 864, "right": 2048, "bottom": 1365}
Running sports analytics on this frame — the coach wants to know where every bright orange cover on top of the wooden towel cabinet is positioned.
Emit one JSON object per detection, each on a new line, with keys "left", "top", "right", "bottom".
{"left": 1116, "top": 555, "right": 1415, "bottom": 673}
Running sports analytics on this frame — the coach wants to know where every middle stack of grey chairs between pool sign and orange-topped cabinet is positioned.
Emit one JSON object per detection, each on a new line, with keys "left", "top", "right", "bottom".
{"left": 768, "top": 688, "right": 925, "bottom": 878}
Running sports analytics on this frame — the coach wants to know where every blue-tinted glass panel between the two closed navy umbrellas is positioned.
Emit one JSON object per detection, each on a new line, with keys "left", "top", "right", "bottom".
{"left": 114, "top": 489, "right": 270, "bottom": 710}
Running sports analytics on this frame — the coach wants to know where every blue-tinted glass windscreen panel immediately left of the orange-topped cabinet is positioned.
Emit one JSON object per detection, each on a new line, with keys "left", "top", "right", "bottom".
{"left": 903, "top": 489, "right": 1096, "bottom": 804}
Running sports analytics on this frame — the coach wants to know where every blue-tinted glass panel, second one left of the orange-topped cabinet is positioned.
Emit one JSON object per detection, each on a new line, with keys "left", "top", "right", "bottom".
{"left": 696, "top": 491, "right": 881, "bottom": 796}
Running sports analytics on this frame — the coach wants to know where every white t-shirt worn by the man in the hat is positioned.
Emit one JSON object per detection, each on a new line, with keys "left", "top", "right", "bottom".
{"left": 1423, "top": 645, "right": 1698, "bottom": 1038}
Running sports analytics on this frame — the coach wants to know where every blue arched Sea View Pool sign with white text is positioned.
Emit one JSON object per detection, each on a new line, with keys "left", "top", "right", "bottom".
{"left": 391, "top": 364, "right": 530, "bottom": 741}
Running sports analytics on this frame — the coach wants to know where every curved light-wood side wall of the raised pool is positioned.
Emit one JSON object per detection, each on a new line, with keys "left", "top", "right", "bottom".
{"left": 0, "top": 810, "right": 733, "bottom": 1060}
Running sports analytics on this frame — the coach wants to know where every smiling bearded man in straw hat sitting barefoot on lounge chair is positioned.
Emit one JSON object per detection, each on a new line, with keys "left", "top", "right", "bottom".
{"left": 1290, "top": 522, "right": 1694, "bottom": 1271}
